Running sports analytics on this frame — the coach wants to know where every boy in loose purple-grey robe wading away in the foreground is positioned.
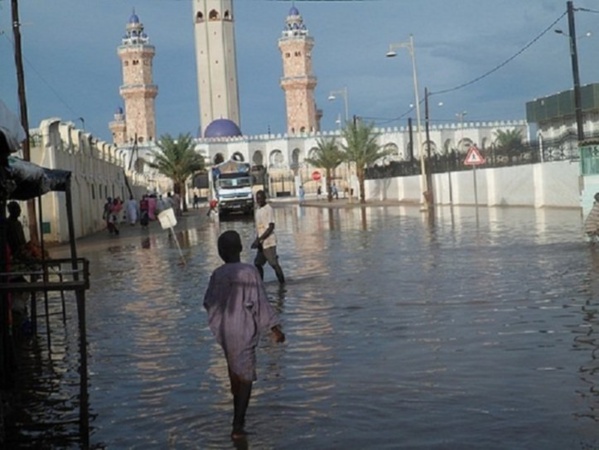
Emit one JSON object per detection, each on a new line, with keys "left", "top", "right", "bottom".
{"left": 204, "top": 230, "right": 285, "bottom": 439}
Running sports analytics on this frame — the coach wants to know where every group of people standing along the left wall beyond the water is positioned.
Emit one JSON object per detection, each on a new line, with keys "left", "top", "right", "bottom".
{"left": 102, "top": 192, "right": 183, "bottom": 235}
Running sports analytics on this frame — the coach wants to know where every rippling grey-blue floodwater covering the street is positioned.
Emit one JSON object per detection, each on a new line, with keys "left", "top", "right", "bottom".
{"left": 7, "top": 205, "right": 599, "bottom": 450}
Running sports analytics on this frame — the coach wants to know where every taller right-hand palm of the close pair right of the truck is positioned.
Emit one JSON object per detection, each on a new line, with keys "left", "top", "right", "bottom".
{"left": 341, "top": 121, "right": 393, "bottom": 203}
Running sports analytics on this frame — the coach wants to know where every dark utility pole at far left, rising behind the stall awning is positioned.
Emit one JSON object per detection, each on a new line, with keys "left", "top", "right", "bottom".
{"left": 11, "top": 0, "right": 39, "bottom": 243}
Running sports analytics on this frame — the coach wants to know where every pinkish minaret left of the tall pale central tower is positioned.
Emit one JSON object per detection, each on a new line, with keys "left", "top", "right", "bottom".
{"left": 110, "top": 10, "right": 158, "bottom": 145}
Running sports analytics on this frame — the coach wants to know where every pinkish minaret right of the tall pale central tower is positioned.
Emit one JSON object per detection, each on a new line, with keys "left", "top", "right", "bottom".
{"left": 279, "top": 6, "right": 322, "bottom": 133}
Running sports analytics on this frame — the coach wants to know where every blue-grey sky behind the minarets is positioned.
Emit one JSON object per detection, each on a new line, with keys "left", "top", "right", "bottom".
{"left": 0, "top": 0, "right": 599, "bottom": 142}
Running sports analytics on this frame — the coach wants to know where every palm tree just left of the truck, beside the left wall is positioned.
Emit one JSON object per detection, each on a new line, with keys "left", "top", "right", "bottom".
{"left": 148, "top": 133, "right": 205, "bottom": 211}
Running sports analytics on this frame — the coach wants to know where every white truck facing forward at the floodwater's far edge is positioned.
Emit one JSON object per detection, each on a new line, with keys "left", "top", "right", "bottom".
{"left": 209, "top": 160, "right": 254, "bottom": 217}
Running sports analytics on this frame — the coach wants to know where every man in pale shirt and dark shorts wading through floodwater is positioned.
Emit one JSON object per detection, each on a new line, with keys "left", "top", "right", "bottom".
{"left": 252, "top": 191, "right": 285, "bottom": 284}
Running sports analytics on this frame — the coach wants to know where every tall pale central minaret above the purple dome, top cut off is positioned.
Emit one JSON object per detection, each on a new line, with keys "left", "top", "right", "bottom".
{"left": 193, "top": 0, "right": 241, "bottom": 136}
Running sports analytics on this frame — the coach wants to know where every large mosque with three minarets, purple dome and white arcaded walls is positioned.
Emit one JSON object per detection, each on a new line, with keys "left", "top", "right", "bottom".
{"left": 110, "top": 0, "right": 592, "bottom": 199}
